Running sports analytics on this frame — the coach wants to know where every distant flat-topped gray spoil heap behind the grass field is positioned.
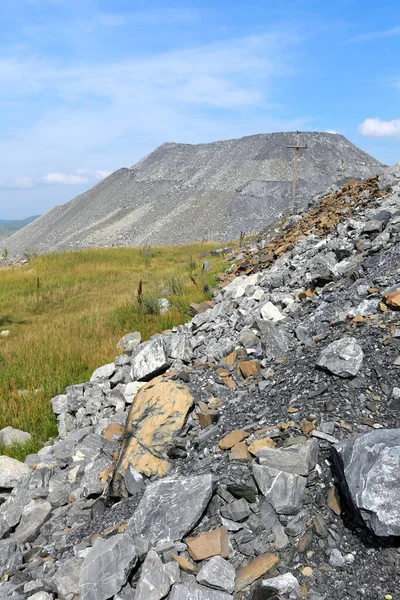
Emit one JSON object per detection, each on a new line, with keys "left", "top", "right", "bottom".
{"left": 0, "top": 132, "right": 382, "bottom": 258}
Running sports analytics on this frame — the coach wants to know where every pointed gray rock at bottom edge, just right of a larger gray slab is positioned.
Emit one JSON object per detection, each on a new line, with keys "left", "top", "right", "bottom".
{"left": 135, "top": 550, "right": 179, "bottom": 600}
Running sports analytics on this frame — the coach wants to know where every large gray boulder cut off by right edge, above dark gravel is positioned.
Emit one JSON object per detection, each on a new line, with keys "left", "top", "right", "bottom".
{"left": 333, "top": 429, "right": 400, "bottom": 536}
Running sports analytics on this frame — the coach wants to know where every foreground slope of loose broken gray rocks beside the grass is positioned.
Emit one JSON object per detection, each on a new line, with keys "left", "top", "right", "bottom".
{"left": 0, "top": 165, "right": 400, "bottom": 600}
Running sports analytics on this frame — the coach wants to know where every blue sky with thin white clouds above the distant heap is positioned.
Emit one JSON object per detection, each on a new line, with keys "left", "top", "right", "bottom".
{"left": 0, "top": 0, "right": 400, "bottom": 219}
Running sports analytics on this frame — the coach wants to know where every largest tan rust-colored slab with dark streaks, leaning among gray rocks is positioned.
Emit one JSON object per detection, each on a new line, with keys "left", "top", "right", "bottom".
{"left": 112, "top": 376, "right": 194, "bottom": 496}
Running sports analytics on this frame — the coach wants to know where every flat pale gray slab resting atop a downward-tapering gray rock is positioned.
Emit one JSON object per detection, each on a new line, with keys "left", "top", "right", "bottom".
{"left": 257, "top": 440, "right": 318, "bottom": 477}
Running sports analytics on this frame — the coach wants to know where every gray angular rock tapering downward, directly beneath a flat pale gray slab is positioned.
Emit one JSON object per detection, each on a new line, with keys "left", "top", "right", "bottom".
{"left": 253, "top": 463, "right": 307, "bottom": 515}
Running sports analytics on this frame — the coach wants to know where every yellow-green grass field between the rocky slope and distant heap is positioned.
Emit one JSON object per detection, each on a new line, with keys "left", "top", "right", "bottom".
{"left": 0, "top": 242, "right": 227, "bottom": 459}
